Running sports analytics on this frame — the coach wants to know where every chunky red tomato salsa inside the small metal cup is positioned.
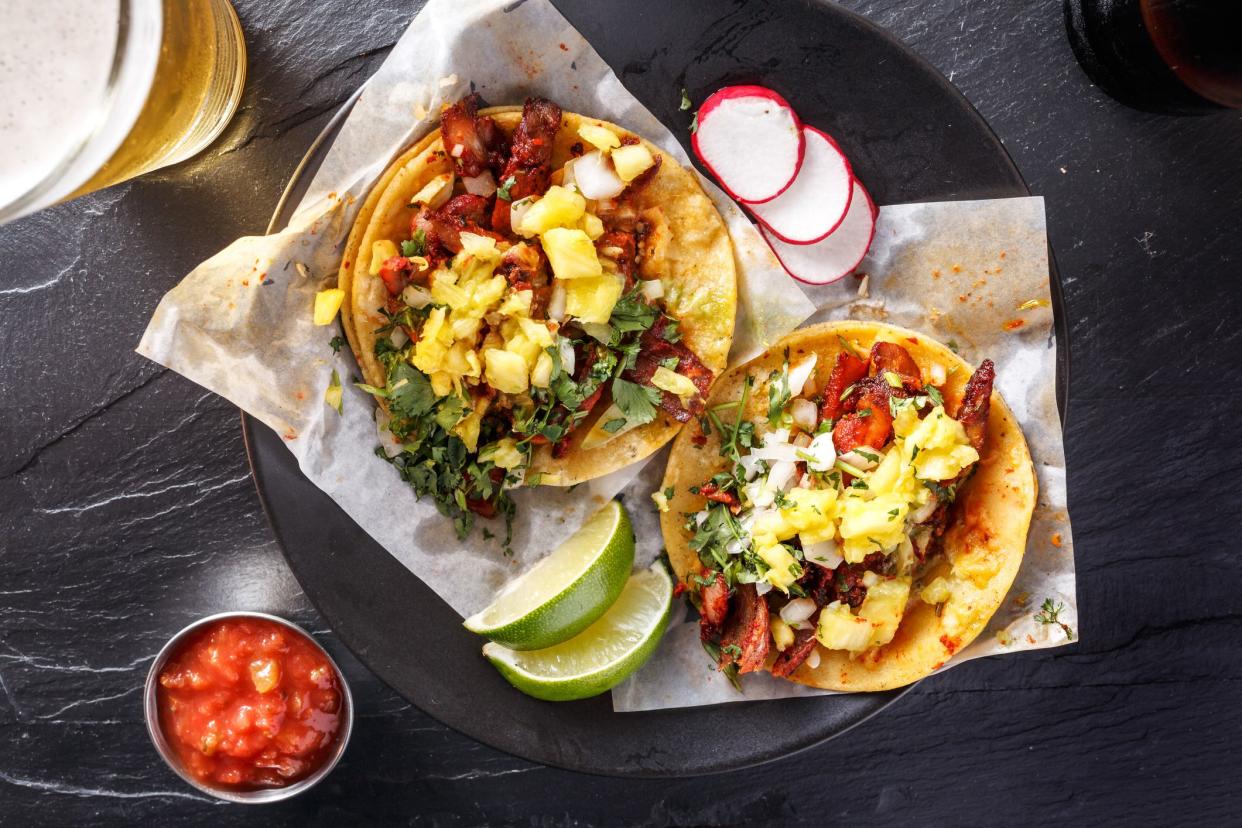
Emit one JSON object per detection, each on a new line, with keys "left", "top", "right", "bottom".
{"left": 156, "top": 618, "right": 344, "bottom": 791}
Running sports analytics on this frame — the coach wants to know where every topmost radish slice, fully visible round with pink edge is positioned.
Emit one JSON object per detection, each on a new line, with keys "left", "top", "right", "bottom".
{"left": 691, "top": 86, "right": 806, "bottom": 204}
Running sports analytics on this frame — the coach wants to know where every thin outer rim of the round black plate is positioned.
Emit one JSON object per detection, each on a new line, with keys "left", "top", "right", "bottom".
{"left": 240, "top": 0, "right": 1071, "bottom": 778}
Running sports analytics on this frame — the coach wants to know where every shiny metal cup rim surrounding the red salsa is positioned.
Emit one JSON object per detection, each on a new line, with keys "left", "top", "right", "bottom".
{"left": 143, "top": 612, "right": 354, "bottom": 804}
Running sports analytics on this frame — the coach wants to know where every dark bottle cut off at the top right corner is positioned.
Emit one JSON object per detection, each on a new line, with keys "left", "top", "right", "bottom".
{"left": 1064, "top": 0, "right": 1242, "bottom": 114}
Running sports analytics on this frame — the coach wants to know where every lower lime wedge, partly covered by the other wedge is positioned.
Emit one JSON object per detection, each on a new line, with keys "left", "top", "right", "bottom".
{"left": 483, "top": 561, "right": 673, "bottom": 701}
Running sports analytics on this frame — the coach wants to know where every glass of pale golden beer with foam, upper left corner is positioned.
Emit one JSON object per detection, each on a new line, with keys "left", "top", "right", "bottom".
{"left": 0, "top": 0, "right": 246, "bottom": 223}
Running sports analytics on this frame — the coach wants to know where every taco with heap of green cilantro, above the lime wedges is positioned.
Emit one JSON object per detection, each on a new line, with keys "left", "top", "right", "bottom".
{"left": 339, "top": 94, "right": 737, "bottom": 543}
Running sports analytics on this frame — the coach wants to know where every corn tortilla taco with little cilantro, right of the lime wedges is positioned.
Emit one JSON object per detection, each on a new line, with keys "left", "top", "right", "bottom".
{"left": 657, "top": 322, "right": 1036, "bottom": 690}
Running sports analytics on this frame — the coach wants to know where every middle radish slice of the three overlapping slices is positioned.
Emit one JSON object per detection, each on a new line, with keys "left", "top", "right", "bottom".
{"left": 750, "top": 127, "right": 853, "bottom": 245}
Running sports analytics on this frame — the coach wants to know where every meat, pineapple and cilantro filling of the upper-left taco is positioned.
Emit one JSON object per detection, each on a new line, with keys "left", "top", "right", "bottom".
{"left": 355, "top": 96, "right": 715, "bottom": 536}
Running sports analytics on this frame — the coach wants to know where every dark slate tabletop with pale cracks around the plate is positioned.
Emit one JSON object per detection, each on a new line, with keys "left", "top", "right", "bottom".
{"left": 0, "top": 0, "right": 1242, "bottom": 826}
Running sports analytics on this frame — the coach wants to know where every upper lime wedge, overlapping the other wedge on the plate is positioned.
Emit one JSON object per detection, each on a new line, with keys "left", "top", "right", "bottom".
{"left": 466, "top": 500, "right": 633, "bottom": 649}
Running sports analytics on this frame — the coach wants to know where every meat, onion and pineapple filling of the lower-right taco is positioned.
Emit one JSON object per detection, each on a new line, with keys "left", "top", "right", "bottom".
{"left": 684, "top": 340, "right": 995, "bottom": 678}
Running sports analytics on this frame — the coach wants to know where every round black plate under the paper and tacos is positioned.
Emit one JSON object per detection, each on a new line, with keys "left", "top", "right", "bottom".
{"left": 242, "top": 0, "right": 1068, "bottom": 776}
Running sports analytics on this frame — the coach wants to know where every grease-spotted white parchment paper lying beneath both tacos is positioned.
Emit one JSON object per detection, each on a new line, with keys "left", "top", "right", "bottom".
{"left": 138, "top": 0, "right": 1077, "bottom": 710}
